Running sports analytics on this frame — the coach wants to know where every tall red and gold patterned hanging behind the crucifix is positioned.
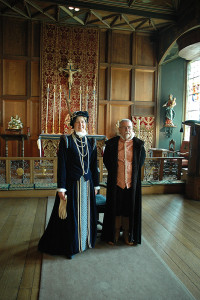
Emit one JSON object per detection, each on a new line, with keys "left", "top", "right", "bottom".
{"left": 41, "top": 24, "right": 99, "bottom": 134}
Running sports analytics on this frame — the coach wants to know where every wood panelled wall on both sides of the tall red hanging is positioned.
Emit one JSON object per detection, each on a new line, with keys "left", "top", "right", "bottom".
{"left": 0, "top": 17, "right": 157, "bottom": 156}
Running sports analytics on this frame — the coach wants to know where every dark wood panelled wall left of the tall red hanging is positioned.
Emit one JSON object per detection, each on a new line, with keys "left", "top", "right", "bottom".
{"left": 0, "top": 18, "right": 40, "bottom": 156}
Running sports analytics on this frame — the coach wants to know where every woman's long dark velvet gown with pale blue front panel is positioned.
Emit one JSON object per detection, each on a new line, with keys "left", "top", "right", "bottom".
{"left": 38, "top": 135, "right": 99, "bottom": 255}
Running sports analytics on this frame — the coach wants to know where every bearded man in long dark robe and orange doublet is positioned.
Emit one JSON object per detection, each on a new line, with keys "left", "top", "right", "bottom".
{"left": 102, "top": 119, "right": 146, "bottom": 245}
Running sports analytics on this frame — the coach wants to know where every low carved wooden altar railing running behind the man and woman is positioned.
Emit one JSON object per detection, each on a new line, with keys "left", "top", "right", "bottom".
{"left": 0, "top": 157, "right": 183, "bottom": 189}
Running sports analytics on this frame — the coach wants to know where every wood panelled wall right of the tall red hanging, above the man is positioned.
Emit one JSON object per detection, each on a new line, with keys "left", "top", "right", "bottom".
{"left": 98, "top": 30, "right": 157, "bottom": 138}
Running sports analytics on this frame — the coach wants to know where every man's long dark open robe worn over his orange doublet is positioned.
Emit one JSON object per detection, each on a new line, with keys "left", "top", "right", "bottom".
{"left": 102, "top": 136, "right": 146, "bottom": 244}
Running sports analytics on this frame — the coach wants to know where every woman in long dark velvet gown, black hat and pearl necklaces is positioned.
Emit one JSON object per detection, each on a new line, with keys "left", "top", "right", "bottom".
{"left": 38, "top": 111, "right": 99, "bottom": 258}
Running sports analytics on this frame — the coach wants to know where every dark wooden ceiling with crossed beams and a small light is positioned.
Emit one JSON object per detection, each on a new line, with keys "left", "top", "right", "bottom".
{"left": 0, "top": 0, "right": 180, "bottom": 33}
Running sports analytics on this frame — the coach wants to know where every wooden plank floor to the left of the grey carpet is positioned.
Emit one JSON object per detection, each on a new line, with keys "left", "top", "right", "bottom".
{"left": 0, "top": 198, "right": 47, "bottom": 300}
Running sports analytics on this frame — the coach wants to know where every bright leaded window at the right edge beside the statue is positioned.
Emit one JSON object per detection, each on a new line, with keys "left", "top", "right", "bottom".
{"left": 184, "top": 60, "right": 200, "bottom": 141}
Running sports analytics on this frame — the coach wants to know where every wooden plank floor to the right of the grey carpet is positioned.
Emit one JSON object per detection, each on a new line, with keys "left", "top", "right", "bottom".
{"left": 143, "top": 194, "right": 200, "bottom": 299}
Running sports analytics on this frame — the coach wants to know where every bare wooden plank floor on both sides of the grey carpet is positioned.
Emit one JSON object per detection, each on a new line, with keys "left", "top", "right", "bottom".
{"left": 0, "top": 194, "right": 200, "bottom": 300}
